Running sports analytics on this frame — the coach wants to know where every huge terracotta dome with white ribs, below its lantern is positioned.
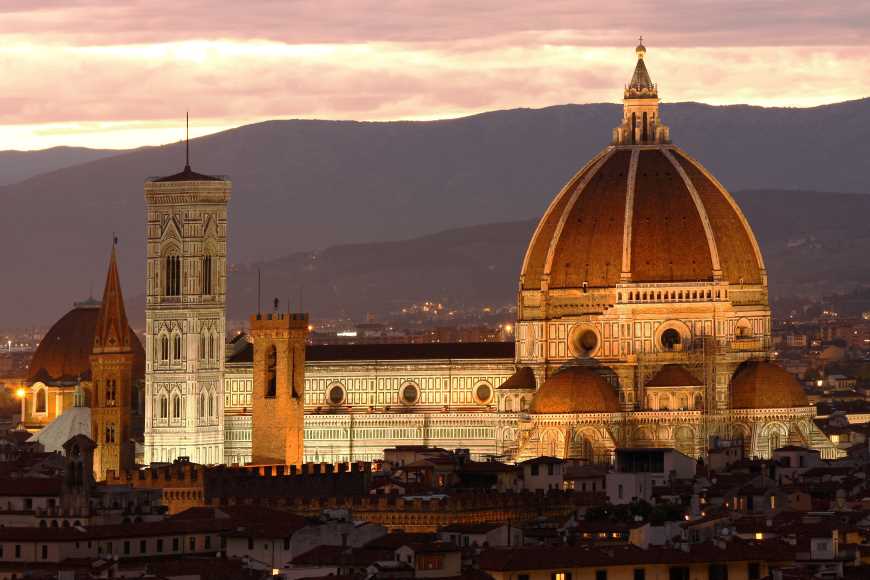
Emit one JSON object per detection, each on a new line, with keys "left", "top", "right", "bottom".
{"left": 521, "top": 144, "right": 764, "bottom": 290}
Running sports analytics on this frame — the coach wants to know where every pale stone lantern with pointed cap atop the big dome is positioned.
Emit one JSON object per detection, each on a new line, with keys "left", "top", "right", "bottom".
{"left": 613, "top": 36, "right": 670, "bottom": 145}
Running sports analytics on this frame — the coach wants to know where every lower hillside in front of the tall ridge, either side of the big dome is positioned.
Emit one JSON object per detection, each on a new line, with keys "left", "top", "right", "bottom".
{"left": 218, "top": 191, "right": 870, "bottom": 320}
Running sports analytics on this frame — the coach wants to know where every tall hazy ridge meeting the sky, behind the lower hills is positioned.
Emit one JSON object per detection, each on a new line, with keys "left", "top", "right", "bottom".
{"left": 0, "top": 99, "right": 870, "bottom": 325}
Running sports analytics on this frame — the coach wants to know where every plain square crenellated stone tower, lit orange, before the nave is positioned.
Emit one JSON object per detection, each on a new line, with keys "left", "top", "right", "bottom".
{"left": 251, "top": 300, "right": 308, "bottom": 465}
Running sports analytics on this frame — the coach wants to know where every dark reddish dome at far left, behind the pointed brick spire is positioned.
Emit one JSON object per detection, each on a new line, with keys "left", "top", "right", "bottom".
{"left": 29, "top": 300, "right": 145, "bottom": 384}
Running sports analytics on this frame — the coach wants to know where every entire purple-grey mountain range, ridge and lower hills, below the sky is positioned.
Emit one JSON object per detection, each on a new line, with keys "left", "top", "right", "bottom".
{"left": 0, "top": 99, "right": 870, "bottom": 327}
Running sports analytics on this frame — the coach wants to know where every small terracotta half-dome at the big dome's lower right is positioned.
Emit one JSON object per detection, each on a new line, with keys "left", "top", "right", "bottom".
{"left": 731, "top": 361, "right": 809, "bottom": 409}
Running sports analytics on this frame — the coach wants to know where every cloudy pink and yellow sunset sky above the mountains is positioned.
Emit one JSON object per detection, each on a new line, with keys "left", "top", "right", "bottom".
{"left": 0, "top": 0, "right": 870, "bottom": 149}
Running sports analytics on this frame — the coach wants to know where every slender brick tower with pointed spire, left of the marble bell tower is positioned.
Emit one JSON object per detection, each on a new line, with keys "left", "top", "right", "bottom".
{"left": 91, "top": 244, "right": 135, "bottom": 480}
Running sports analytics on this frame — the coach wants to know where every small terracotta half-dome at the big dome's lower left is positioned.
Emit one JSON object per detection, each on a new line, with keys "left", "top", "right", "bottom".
{"left": 529, "top": 367, "right": 619, "bottom": 413}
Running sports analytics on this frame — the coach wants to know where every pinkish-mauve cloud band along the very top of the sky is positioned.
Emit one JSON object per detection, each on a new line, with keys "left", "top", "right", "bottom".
{"left": 0, "top": 0, "right": 870, "bottom": 46}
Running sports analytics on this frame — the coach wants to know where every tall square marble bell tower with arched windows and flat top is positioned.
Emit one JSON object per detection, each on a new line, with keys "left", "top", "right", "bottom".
{"left": 145, "top": 155, "right": 232, "bottom": 464}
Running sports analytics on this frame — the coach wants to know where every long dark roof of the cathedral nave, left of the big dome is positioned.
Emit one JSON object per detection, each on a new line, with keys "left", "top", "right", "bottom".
{"left": 228, "top": 342, "right": 514, "bottom": 364}
